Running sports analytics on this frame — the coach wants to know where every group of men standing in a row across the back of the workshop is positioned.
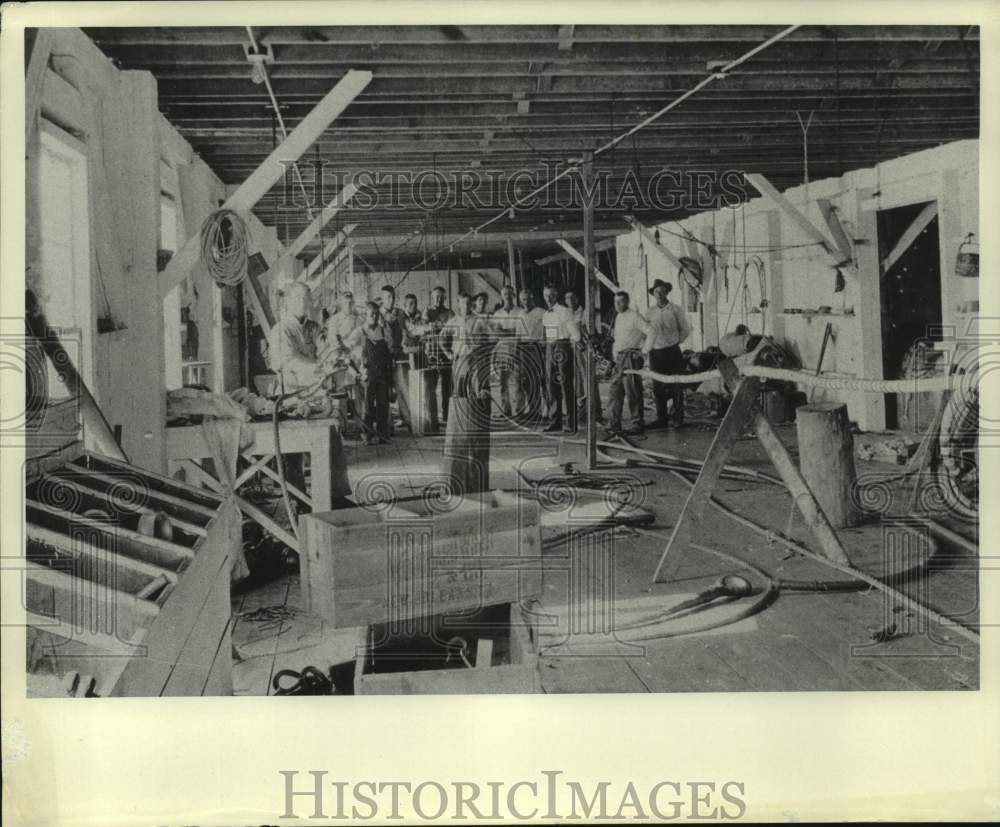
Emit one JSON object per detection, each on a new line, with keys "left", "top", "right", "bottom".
{"left": 270, "top": 280, "right": 690, "bottom": 443}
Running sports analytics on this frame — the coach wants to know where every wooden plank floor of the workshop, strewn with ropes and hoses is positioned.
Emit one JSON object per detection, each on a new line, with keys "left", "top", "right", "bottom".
{"left": 233, "top": 410, "right": 979, "bottom": 695}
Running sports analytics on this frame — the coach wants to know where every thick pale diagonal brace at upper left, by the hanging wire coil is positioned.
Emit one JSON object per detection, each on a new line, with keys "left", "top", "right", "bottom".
{"left": 158, "top": 69, "right": 372, "bottom": 298}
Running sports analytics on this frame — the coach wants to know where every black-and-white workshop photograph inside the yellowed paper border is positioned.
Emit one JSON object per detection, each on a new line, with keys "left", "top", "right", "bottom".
{"left": 0, "top": 3, "right": 1000, "bottom": 823}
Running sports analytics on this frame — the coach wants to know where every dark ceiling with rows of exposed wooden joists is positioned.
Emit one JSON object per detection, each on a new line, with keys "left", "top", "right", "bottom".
{"left": 85, "top": 25, "right": 979, "bottom": 269}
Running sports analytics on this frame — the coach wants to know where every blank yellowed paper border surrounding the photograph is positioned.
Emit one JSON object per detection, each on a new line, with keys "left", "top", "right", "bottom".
{"left": 0, "top": 0, "right": 1000, "bottom": 827}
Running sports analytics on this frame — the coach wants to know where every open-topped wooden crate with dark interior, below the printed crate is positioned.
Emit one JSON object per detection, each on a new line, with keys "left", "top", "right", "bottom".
{"left": 354, "top": 603, "right": 541, "bottom": 695}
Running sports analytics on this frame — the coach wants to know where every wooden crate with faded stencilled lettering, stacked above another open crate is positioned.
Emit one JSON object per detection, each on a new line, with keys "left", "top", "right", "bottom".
{"left": 299, "top": 492, "right": 542, "bottom": 627}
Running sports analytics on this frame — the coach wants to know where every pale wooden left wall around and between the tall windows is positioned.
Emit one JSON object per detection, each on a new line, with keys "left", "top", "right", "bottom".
{"left": 27, "top": 28, "right": 236, "bottom": 471}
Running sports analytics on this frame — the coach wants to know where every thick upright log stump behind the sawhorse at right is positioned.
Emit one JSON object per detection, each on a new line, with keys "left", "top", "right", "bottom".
{"left": 795, "top": 402, "right": 861, "bottom": 528}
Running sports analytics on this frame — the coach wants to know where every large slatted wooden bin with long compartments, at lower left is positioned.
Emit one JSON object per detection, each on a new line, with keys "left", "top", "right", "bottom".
{"left": 24, "top": 454, "right": 242, "bottom": 696}
